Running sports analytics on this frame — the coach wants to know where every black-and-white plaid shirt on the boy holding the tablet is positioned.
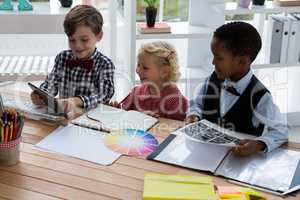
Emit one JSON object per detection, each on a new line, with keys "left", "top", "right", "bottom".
{"left": 40, "top": 49, "right": 115, "bottom": 108}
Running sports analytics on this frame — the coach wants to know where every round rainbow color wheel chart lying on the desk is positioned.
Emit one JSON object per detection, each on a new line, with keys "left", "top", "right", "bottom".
{"left": 105, "top": 129, "right": 158, "bottom": 156}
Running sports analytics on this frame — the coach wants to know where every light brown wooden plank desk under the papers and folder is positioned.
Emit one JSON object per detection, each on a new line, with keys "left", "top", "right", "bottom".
{"left": 0, "top": 119, "right": 300, "bottom": 200}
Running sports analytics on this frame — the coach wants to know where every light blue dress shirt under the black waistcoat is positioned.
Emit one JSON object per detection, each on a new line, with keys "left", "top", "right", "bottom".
{"left": 187, "top": 70, "right": 288, "bottom": 152}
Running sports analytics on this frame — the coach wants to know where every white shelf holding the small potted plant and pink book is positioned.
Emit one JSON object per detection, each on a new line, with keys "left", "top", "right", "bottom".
{"left": 136, "top": 22, "right": 214, "bottom": 40}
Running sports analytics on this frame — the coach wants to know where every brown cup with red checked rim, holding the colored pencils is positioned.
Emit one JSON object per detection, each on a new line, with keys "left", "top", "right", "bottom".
{"left": 0, "top": 137, "right": 21, "bottom": 166}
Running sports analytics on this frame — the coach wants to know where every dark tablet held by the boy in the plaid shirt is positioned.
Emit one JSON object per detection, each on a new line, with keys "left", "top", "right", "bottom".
{"left": 28, "top": 83, "right": 66, "bottom": 116}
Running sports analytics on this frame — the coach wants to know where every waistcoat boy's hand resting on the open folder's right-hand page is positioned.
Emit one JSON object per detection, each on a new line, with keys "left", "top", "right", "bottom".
{"left": 232, "top": 140, "right": 267, "bottom": 156}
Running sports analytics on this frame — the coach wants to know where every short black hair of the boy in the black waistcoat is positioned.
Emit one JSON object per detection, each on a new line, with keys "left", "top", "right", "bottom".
{"left": 213, "top": 21, "right": 262, "bottom": 62}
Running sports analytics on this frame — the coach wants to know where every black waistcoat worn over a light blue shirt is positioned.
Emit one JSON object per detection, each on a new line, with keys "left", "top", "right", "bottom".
{"left": 202, "top": 72, "right": 269, "bottom": 136}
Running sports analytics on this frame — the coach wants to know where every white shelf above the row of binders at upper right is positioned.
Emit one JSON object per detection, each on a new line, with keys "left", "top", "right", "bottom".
{"left": 224, "top": 1, "right": 300, "bottom": 15}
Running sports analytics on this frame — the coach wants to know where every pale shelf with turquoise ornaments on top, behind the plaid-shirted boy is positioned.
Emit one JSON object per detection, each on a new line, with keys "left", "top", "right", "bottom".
{"left": 0, "top": 0, "right": 107, "bottom": 34}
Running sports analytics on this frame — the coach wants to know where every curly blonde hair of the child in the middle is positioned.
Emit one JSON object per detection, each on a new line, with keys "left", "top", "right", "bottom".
{"left": 138, "top": 41, "right": 180, "bottom": 82}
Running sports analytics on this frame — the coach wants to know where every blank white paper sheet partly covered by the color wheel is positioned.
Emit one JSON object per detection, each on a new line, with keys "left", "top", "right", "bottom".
{"left": 36, "top": 124, "right": 121, "bottom": 165}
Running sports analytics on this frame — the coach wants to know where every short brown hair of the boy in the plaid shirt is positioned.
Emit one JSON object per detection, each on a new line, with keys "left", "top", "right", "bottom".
{"left": 64, "top": 5, "right": 103, "bottom": 36}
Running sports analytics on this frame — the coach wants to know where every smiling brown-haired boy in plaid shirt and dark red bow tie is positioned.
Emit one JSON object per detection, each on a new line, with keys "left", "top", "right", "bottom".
{"left": 31, "top": 5, "right": 115, "bottom": 112}
